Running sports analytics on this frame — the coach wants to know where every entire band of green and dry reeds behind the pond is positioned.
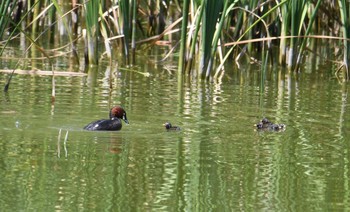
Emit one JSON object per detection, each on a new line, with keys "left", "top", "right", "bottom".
{"left": 0, "top": 0, "right": 350, "bottom": 81}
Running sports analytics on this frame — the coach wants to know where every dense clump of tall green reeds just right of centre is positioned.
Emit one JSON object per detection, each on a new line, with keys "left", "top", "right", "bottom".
{"left": 178, "top": 0, "right": 231, "bottom": 77}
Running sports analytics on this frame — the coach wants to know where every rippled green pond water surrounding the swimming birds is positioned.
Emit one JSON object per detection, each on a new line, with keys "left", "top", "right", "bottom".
{"left": 0, "top": 61, "right": 350, "bottom": 211}
